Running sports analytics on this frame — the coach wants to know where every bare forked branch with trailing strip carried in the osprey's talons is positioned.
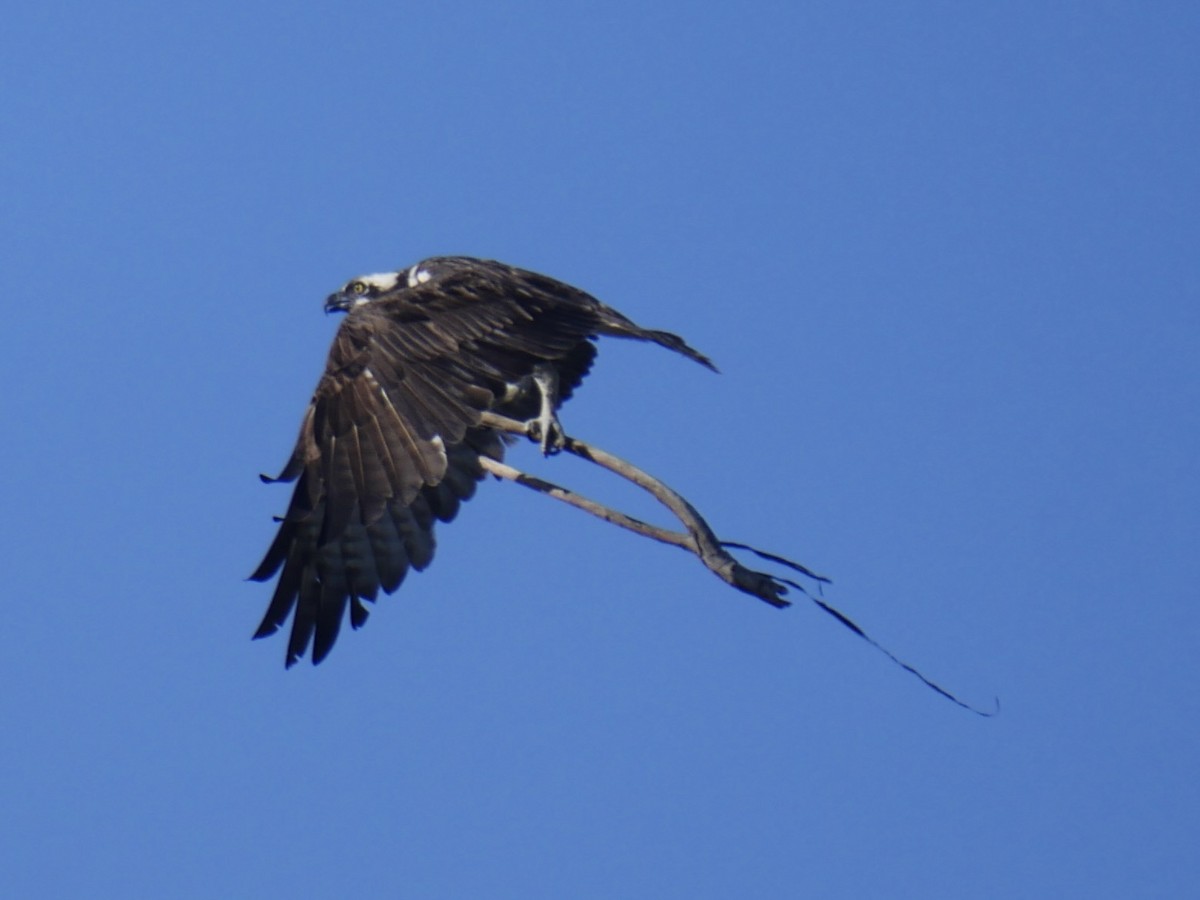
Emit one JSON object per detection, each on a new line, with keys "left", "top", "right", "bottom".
{"left": 480, "top": 413, "right": 1000, "bottom": 716}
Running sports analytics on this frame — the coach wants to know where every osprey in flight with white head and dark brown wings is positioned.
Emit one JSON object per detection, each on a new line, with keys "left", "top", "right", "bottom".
{"left": 250, "top": 257, "right": 716, "bottom": 667}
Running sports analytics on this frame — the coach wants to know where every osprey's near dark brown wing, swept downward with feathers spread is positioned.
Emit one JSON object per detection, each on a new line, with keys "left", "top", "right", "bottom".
{"left": 251, "top": 266, "right": 609, "bottom": 666}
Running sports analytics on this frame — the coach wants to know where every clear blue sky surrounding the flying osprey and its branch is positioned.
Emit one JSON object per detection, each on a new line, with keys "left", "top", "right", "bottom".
{"left": 0, "top": 1, "right": 1200, "bottom": 898}
